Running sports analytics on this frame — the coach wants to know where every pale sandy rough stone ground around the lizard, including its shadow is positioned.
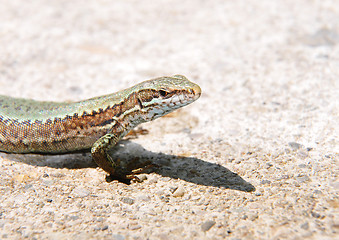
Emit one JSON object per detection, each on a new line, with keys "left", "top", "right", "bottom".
{"left": 0, "top": 0, "right": 339, "bottom": 240}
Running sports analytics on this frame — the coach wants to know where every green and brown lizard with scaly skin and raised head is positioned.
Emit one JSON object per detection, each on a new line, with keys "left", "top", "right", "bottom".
{"left": 0, "top": 75, "right": 201, "bottom": 178}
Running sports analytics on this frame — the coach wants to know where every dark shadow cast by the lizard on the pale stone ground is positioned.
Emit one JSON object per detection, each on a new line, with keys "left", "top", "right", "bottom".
{"left": 2, "top": 140, "right": 255, "bottom": 192}
